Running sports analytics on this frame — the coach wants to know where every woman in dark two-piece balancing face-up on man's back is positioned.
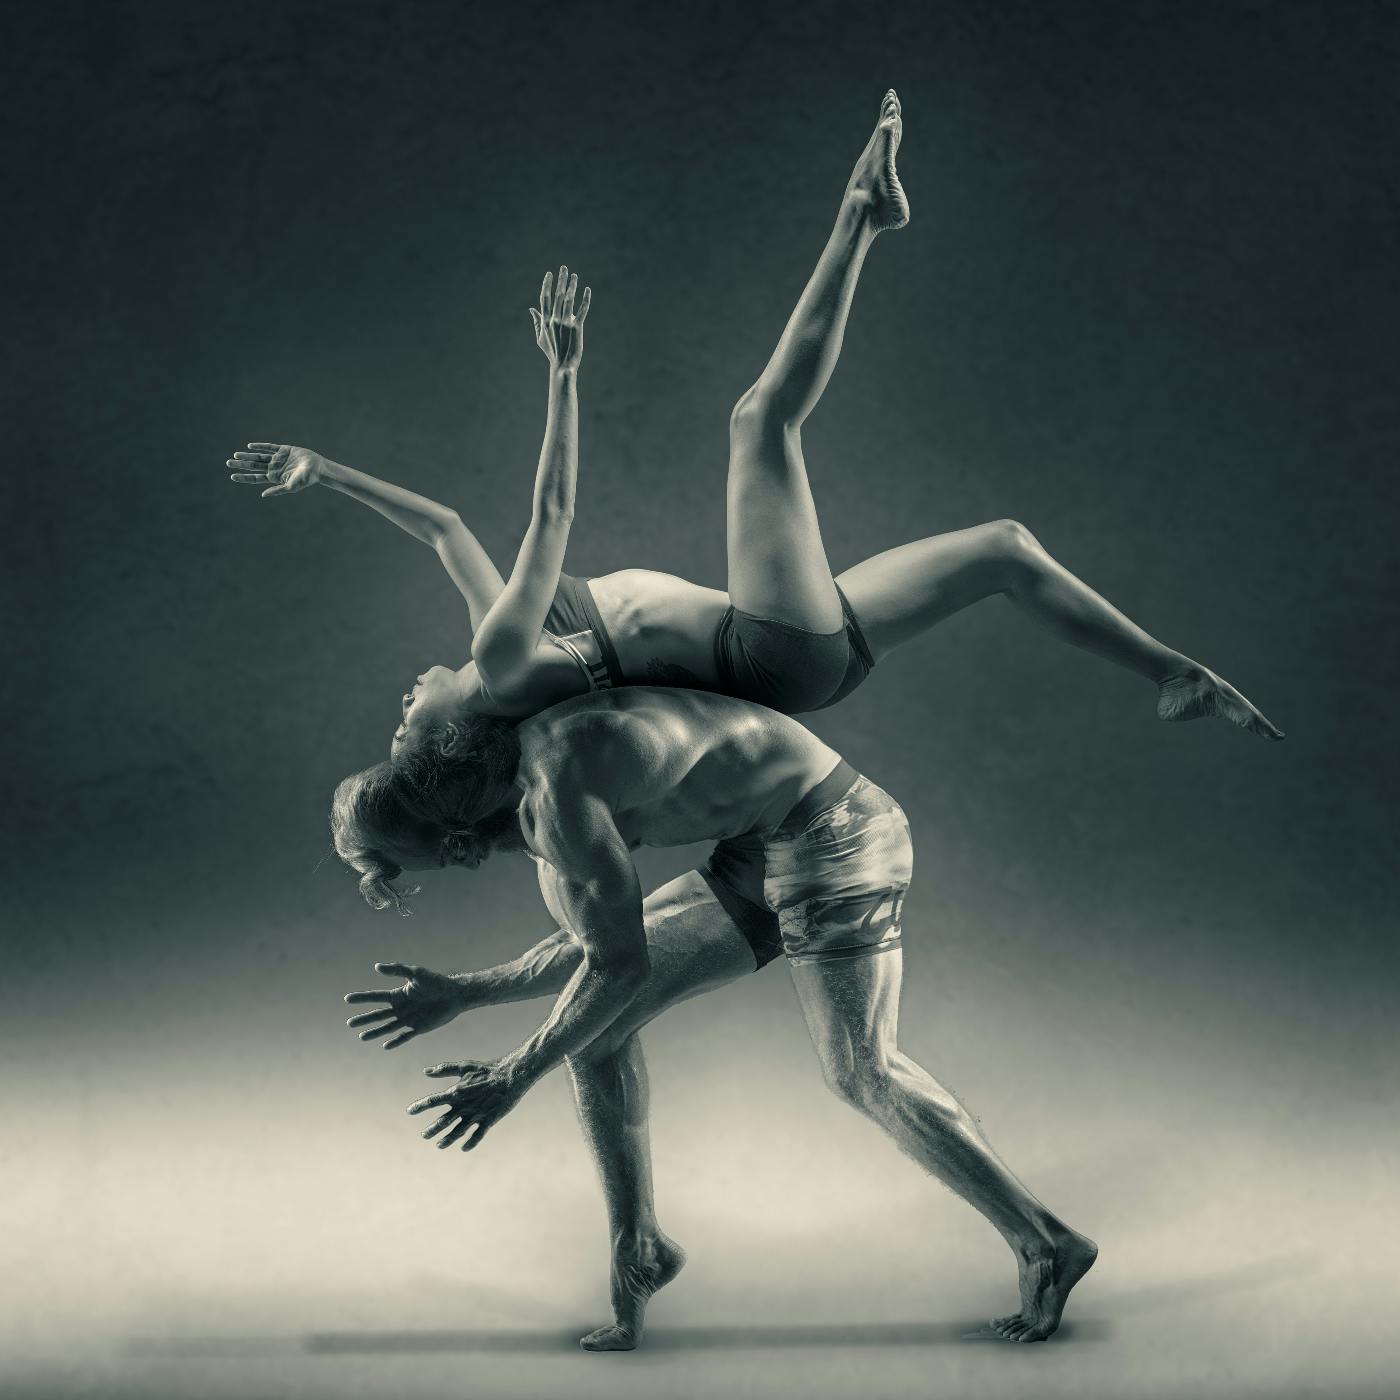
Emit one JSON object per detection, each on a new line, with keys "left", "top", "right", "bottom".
{"left": 228, "top": 91, "right": 1282, "bottom": 907}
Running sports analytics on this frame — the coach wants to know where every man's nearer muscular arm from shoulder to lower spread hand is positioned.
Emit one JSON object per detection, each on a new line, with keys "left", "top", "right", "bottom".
{"left": 409, "top": 774, "right": 651, "bottom": 1151}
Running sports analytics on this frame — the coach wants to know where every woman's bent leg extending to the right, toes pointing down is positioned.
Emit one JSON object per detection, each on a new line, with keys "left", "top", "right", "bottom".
{"left": 837, "top": 521, "right": 1284, "bottom": 739}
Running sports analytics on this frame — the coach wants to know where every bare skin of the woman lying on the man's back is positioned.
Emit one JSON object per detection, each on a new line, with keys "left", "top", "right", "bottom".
{"left": 228, "top": 92, "right": 1282, "bottom": 742}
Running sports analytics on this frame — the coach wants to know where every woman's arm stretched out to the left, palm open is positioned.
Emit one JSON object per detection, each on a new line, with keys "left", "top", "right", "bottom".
{"left": 228, "top": 442, "right": 505, "bottom": 633}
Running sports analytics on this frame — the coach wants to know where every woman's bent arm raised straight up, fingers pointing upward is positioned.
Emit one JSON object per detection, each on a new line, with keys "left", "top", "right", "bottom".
{"left": 472, "top": 267, "right": 592, "bottom": 686}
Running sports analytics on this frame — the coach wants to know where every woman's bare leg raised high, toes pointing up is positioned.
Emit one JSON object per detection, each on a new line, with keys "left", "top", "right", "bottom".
{"left": 727, "top": 91, "right": 909, "bottom": 633}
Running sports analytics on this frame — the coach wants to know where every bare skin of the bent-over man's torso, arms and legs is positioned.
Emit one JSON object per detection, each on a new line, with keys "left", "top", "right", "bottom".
{"left": 341, "top": 687, "right": 1095, "bottom": 1350}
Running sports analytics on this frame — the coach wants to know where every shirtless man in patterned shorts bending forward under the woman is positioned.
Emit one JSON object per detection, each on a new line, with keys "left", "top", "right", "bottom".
{"left": 340, "top": 687, "right": 1098, "bottom": 1350}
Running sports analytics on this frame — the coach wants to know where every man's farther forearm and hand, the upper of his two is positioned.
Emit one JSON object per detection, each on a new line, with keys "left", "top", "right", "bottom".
{"left": 346, "top": 928, "right": 584, "bottom": 1050}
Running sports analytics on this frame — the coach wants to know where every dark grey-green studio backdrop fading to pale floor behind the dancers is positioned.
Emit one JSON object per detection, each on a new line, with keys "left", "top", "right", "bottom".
{"left": 0, "top": 0, "right": 1400, "bottom": 1396}
